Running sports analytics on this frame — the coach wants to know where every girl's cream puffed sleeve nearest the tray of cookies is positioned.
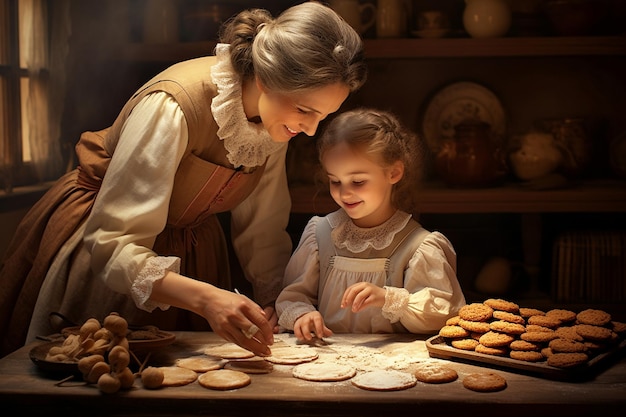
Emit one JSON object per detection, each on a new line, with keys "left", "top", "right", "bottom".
{"left": 383, "top": 232, "right": 465, "bottom": 333}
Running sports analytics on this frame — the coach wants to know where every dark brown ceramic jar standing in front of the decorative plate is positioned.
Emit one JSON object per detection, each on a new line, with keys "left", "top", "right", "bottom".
{"left": 436, "top": 120, "right": 503, "bottom": 187}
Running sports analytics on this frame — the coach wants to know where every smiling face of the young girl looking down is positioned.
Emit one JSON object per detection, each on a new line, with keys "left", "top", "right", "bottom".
{"left": 322, "top": 143, "right": 404, "bottom": 227}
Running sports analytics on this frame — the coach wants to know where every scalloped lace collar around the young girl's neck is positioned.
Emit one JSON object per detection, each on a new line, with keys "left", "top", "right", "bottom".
{"left": 328, "top": 210, "right": 411, "bottom": 253}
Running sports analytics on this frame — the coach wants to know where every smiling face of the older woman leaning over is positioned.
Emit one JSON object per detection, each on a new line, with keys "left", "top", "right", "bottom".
{"left": 257, "top": 83, "right": 350, "bottom": 142}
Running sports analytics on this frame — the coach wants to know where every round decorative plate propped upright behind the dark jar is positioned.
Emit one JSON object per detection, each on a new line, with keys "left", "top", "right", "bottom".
{"left": 422, "top": 81, "right": 506, "bottom": 152}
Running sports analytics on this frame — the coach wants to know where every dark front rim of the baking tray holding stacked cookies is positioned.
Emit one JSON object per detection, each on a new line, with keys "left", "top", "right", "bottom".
{"left": 426, "top": 335, "right": 626, "bottom": 380}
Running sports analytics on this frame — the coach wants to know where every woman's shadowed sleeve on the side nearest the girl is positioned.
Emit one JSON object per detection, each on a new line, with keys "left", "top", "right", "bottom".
{"left": 231, "top": 144, "right": 292, "bottom": 306}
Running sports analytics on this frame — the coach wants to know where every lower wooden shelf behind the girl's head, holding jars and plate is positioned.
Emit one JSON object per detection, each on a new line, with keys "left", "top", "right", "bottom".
{"left": 290, "top": 180, "right": 626, "bottom": 214}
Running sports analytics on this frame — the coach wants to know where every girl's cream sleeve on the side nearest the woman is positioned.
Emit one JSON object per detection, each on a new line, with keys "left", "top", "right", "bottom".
{"left": 276, "top": 216, "right": 321, "bottom": 330}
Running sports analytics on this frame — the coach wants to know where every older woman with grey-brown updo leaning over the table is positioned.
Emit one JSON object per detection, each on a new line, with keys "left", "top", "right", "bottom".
{"left": 0, "top": 2, "right": 366, "bottom": 355}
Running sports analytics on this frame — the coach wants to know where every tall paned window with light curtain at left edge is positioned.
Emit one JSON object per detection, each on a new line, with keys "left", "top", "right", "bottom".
{"left": 0, "top": 0, "right": 69, "bottom": 194}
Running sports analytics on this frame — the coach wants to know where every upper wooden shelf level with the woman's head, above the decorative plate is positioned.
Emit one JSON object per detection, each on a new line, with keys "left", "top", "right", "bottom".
{"left": 111, "top": 36, "right": 626, "bottom": 62}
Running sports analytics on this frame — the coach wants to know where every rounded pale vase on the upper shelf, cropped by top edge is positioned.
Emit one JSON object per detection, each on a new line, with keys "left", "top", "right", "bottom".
{"left": 463, "top": 0, "right": 511, "bottom": 38}
